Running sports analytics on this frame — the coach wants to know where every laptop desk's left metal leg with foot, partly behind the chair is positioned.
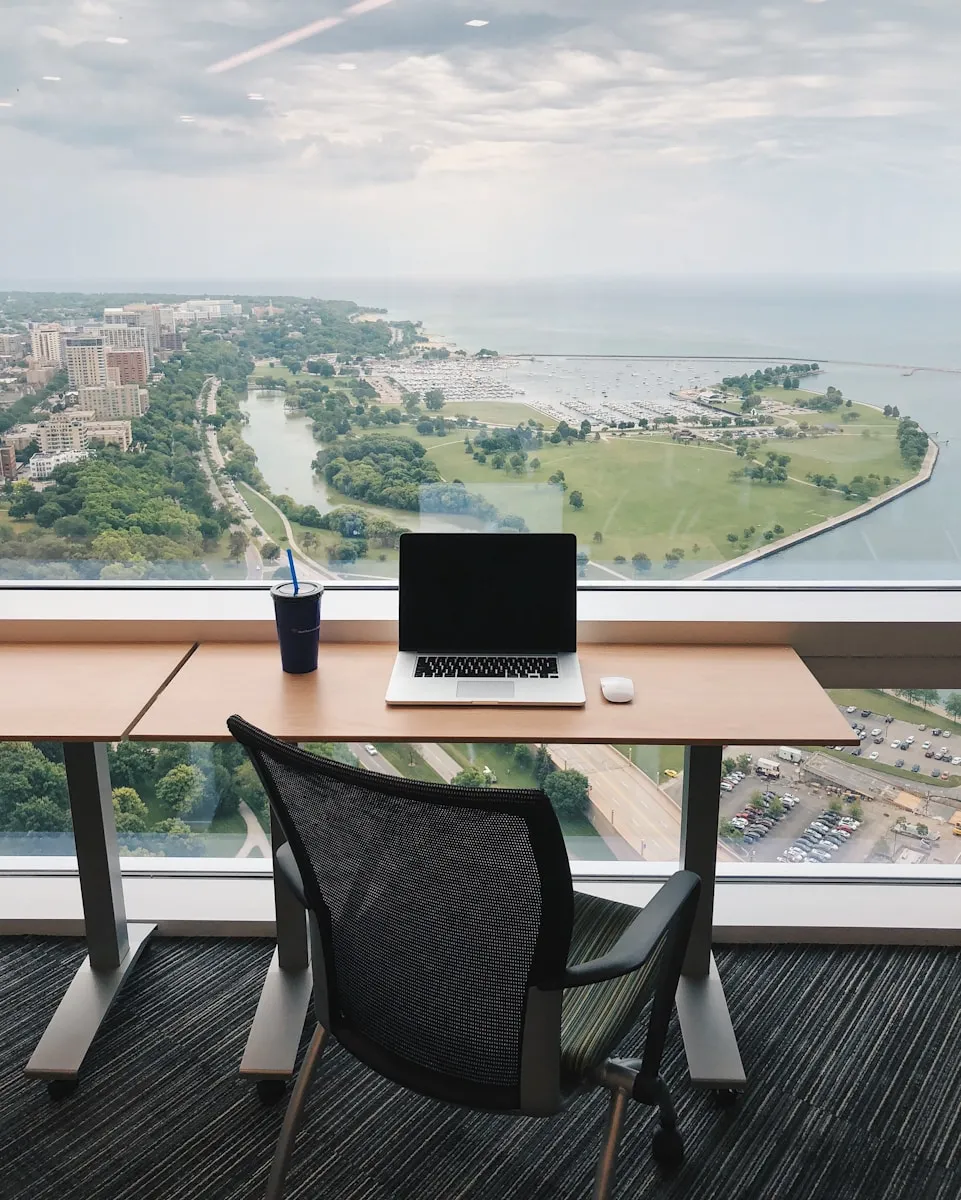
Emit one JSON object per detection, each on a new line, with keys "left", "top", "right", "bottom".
{"left": 240, "top": 814, "right": 312, "bottom": 1099}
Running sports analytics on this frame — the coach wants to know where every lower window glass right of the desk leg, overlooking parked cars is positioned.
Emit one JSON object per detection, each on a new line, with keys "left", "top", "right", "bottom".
{"left": 720, "top": 689, "right": 961, "bottom": 869}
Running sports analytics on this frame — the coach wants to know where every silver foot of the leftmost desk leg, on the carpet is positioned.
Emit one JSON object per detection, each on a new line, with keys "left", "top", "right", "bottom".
{"left": 24, "top": 924, "right": 157, "bottom": 1084}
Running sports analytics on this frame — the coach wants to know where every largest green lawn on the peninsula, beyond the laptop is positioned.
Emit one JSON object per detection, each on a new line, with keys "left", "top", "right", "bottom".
{"left": 424, "top": 434, "right": 887, "bottom": 568}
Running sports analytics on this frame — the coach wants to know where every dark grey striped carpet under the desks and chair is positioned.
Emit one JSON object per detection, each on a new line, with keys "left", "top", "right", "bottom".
{"left": 0, "top": 937, "right": 961, "bottom": 1200}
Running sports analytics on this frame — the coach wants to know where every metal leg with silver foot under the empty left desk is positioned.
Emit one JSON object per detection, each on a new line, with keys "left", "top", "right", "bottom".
{"left": 25, "top": 742, "right": 156, "bottom": 1093}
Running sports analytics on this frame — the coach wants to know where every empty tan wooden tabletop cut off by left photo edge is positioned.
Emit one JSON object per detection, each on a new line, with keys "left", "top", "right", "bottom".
{"left": 0, "top": 642, "right": 192, "bottom": 742}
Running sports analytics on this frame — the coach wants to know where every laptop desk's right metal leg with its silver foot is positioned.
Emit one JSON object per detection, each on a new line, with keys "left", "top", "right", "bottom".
{"left": 677, "top": 746, "right": 746, "bottom": 1092}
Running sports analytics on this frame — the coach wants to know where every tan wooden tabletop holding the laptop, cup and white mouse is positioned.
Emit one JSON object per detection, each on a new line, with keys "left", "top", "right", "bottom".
{"left": 130, "top": 643, "right": 854, "bottom": 745}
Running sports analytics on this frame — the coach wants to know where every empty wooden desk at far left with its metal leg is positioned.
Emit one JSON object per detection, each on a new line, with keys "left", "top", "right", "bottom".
{"left": 0, "top": 643, "right": 193, "bottom": 1094}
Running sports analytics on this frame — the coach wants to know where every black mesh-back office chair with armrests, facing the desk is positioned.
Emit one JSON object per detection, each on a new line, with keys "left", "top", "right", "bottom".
{"left": 227, "top": 716, "right": 701, "bottom": 1200}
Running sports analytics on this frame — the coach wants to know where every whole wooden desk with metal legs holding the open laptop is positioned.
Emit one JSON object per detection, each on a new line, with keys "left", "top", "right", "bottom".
{"left": 130, "top": 643, "right": 857, "bottom": 1090}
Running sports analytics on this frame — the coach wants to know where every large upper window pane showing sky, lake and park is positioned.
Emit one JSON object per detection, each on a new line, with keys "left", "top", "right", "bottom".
{"left": 0, "top": 0, "right": 961, "bottom": 583}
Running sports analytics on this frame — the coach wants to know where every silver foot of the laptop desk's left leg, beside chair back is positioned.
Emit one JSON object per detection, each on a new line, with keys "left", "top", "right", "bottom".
{"left": 240, "top": 949, "right": 313, "bottom": 1084}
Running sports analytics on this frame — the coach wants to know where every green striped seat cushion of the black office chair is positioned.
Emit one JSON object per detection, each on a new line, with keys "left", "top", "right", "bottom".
{"left": 560, "top": 892, "right": 663, "bottom": 1091}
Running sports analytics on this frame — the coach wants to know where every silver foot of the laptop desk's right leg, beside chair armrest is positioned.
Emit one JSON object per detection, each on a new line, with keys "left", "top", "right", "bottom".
{"left": 677, "top": 954, "right": 747, "bottom": 1104}
